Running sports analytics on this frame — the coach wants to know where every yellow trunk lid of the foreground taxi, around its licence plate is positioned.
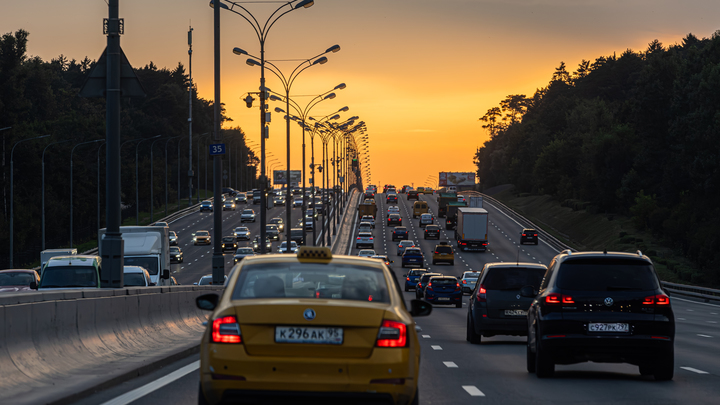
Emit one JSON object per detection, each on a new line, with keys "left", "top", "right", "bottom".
{"left": 236, "top": 299, "right": 388, "bottom": 358}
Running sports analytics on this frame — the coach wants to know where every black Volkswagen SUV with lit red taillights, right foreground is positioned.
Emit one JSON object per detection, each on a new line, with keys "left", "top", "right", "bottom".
{"left": 520, "top": 250, "right": 675, "bottom": 381}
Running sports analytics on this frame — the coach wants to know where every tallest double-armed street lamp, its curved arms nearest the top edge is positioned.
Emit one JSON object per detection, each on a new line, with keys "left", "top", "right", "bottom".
{"left": 210, "top": 0, "right": 315, "bottom": 254}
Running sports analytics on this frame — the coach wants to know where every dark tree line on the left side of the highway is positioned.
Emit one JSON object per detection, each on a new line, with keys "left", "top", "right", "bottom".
{"left": 0, "top": 30, "right": 257, "bottom": 268}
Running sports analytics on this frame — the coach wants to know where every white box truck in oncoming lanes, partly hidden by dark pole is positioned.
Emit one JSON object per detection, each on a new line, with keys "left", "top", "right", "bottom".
{"left": 99, "top": 226, "right": 170, "bottom": 285}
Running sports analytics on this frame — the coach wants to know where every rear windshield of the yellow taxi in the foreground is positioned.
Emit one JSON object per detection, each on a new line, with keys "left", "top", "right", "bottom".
{"left": 232, "top": 263, "right": 390, "bottom": 303}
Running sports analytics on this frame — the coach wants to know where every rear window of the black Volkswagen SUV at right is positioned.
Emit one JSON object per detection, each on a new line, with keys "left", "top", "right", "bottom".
{"left": 557, "top": 259, "right": 658, "bottom": 291}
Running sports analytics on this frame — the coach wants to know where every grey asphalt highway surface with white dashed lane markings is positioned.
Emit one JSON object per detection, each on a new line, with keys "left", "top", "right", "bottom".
{"left": 73, "top": 194, "right": 720, "bottom": 405}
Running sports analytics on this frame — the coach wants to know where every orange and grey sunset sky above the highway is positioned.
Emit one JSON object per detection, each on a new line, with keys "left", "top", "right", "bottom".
{"left": 0, "top": 0, "right": 720, "bottom": 187}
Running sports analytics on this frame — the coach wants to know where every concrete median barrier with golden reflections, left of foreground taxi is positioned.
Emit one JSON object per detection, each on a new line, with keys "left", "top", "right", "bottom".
{"left": 0, "top": 286, "right": 222, "bottom": 404}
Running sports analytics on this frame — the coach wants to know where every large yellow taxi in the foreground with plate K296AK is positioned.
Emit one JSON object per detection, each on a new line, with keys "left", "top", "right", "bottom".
{"left": 196, "top": 246, "right": 432, "bottom": 404}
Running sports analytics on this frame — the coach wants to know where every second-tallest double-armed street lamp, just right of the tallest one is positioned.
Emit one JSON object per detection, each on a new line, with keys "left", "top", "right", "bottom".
{"left": 233, "top": 45, "right": 340, "bottom": 253}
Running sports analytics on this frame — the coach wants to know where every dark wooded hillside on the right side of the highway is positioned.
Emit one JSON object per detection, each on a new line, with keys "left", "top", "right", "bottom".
{"left": 475, "top": 31, "right": 720, "bottom": 285}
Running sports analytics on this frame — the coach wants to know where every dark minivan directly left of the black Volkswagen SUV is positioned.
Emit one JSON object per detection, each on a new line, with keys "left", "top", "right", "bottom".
{"left": 467, "top": 262, "right": 547, "bottom": 344}
